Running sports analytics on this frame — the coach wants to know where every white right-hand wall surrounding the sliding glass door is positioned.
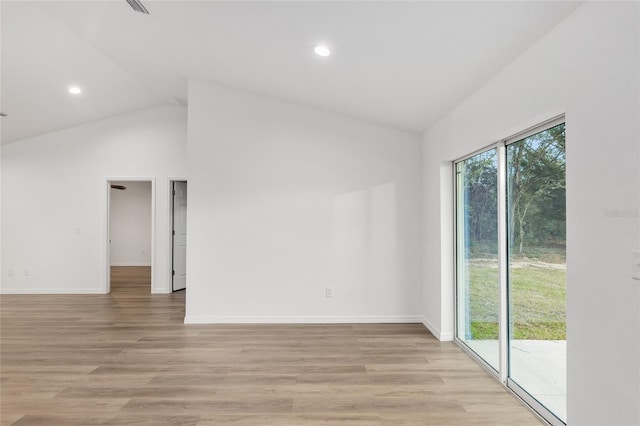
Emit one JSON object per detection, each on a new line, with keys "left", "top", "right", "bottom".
{"left": 423, "top": 2, "right": 640, "bottom": 425}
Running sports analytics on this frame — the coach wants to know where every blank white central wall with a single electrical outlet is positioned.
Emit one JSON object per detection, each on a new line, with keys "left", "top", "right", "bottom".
{"left": 186, "top": 81, "right": 422, "bottom": 322}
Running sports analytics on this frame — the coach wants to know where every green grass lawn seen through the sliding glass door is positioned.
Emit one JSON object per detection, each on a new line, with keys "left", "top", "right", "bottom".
{"left": 468, "top": 261, "right": 566, "bottom": 340}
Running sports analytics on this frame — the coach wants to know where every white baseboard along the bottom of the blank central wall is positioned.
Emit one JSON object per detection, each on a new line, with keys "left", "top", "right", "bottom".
{"left": 184, "top": 315, "right": 422, "bottom": 324}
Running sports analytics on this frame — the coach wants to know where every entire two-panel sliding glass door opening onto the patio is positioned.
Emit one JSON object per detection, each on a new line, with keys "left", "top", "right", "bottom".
{"left": 455, "top": 119, "right": 566, "bottom": 424}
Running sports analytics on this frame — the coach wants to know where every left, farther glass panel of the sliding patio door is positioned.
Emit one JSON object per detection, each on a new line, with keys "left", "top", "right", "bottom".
{"left": 456, "top": 149, "right": 500, "bottom": 371}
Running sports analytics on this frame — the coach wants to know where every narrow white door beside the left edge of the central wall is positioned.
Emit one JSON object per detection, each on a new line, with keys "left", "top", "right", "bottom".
{"left": 173, "top": 181, "right": 187, "bottom": 291}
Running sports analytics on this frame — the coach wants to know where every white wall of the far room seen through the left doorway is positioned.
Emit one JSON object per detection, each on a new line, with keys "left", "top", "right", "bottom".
{"left": 109, "top": 181, "right": 152, "bottom": 266}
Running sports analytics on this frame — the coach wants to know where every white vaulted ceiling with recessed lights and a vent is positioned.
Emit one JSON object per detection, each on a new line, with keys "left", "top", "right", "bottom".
{"left": 0, "top": 0, "right": 580, "bottom": 143}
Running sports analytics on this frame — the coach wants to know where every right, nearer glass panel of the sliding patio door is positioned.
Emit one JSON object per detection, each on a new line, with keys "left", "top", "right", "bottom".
{"left": 506, "top": 124, "right": 567, "bottom": 422}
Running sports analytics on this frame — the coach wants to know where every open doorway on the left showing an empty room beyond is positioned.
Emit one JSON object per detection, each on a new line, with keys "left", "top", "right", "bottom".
{"left": 105, "top": 178, "right": 155, "bottom": 294}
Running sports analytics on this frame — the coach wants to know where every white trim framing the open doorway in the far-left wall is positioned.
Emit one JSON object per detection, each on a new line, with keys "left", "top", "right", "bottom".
{"left": 102, "top": 176, "right": 156, "bottom": 294}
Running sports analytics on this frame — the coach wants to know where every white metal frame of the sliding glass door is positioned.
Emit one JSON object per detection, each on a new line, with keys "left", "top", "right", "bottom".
{"left": 452, "top": 114, "right": 566, "bottom": 426}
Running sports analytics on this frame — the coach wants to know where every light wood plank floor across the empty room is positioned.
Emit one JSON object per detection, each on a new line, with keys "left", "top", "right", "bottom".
{"left": 0, "top": 268, "right": 540, "bottom": 426}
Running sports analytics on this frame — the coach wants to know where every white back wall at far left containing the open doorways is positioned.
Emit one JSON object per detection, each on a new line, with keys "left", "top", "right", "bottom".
{"left": 1, "top": 106, "right": 186, "bottom": 293}
